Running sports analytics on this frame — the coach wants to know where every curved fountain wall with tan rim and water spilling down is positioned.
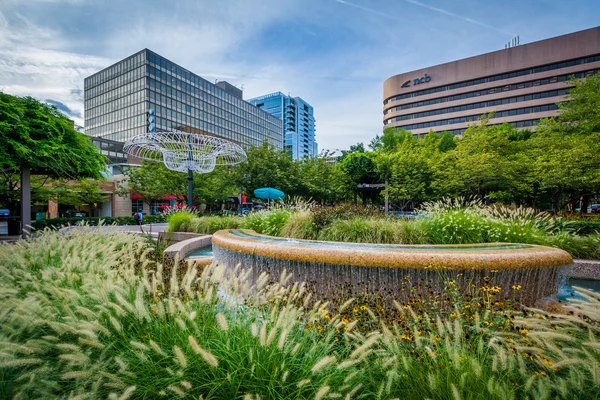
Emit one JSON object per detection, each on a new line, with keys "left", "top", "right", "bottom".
{"left": 212, "top": 230, "right": 573, "bottom": 305}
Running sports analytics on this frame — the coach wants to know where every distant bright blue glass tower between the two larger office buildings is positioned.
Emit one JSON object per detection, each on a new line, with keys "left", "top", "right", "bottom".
{"left": 248, "top": 92, "right": 318, "bottom": 160}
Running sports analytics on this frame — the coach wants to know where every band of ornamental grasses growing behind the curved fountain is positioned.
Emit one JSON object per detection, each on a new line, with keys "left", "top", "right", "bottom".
{"left": 169, "top": 198, "right": 600, "bottom": 260}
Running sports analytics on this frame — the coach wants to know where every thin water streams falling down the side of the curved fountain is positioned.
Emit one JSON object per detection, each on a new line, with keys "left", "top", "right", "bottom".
{"left": 213, "top": 239, "right": 569, "bottom": 305}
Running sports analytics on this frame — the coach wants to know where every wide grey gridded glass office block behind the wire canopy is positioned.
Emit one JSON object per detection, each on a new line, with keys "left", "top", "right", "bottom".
{"left": 84, "top": 49, "right": 283, "bottom": 149}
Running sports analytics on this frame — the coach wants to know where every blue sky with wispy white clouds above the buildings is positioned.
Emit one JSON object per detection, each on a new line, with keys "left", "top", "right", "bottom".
{"left": 0, "top": 0, "right": 600, "bottom": 150}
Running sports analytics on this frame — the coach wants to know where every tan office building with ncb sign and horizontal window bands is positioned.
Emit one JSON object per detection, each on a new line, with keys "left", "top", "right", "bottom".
{"left": 383, "top": 27, "right": 600, "bottom": 135}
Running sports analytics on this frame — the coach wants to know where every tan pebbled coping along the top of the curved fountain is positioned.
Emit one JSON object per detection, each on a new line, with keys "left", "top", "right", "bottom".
{"left": 212, "top": 229, "right": 573, "bottom": 270}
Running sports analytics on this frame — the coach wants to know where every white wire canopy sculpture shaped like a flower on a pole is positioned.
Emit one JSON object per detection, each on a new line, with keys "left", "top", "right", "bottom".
{"left": 123, "top": 131, "right": 246, "bottom": 207}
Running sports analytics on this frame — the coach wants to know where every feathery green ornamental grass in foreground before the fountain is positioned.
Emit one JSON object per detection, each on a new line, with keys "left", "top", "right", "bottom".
{"left": 0, "top": 230, "right": 600, "bottom": 399}
